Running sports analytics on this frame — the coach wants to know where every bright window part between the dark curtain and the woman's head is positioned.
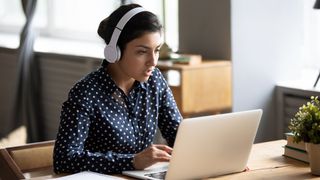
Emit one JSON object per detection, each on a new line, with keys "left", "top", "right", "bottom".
{"left": 43, "top": 0, "right": 120, "bottom": 40}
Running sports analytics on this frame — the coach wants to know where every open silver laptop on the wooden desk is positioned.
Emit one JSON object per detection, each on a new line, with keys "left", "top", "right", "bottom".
{"left": 122, "top": 109, "right": 262, "bottom": 180}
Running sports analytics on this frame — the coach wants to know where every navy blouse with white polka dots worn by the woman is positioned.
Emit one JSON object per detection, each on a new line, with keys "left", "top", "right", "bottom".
{"left": 53, "top": 62, "right": 182, "bottom": 173}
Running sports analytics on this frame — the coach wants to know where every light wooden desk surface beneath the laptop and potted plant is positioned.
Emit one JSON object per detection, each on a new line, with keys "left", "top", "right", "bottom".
{"left": 31, "top": 140, "right": 320, "bottom": 180}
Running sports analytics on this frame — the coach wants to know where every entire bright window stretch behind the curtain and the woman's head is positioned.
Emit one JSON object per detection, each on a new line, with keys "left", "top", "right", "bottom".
{"left": 0, "top": 0, "right": 178, "bottom": 50}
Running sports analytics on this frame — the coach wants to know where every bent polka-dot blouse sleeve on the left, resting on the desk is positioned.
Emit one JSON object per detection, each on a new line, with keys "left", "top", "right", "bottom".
{"left": 53, "top": 86, "right": 134, "bottom": 173}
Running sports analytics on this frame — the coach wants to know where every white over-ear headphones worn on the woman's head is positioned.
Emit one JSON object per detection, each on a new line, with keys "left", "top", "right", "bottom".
{"left": 104, "top": 7, "right": 146, "bottom": 63}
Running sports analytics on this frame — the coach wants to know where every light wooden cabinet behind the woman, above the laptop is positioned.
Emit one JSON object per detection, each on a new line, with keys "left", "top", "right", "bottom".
{"left": 158, "top": 60, "right": 232, "bottom": 117}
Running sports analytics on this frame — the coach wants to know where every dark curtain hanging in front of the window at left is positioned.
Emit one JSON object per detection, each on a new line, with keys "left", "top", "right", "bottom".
{"left": 14, "top": 0, "right": 43, "bottom": 142}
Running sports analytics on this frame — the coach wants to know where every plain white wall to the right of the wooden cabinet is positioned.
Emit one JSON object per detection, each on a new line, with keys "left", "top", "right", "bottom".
{"left": 231, "top": 0, "right": 303, "bottom": 142}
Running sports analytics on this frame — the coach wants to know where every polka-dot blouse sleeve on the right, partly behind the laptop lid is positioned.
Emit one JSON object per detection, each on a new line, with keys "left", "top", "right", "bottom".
{"left": 158, "top": 71, "right": 182, "bottom": 147}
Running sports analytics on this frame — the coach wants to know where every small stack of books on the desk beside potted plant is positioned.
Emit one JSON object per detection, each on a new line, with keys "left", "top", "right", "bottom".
{"left": 283, "top": 133, "right": 309, "bottom": 163}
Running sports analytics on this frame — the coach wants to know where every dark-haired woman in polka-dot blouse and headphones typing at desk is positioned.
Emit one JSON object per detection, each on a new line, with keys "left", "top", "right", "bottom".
{"left": 53, "top": 4, "right": 182, "bottom": 173}
